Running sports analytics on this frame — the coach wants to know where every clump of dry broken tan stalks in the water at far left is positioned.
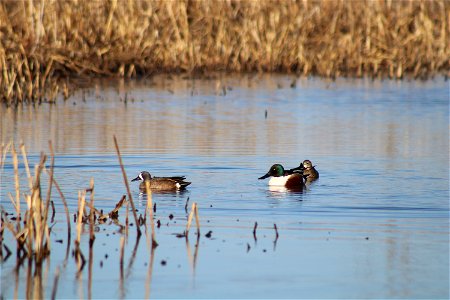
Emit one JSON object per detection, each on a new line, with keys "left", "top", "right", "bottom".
{"left": 0, "top": 142, "right": 131, "bottom": 271}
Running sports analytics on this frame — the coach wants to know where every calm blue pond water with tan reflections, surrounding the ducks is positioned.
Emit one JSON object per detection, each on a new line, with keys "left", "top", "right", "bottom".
{"left": 0, "top": 76, "right": 449, "bottom": 298}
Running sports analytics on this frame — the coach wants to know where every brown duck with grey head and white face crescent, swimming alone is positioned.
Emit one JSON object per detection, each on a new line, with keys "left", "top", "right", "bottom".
{"left": 131, "top": 171, "right": 191, "bottom": 192}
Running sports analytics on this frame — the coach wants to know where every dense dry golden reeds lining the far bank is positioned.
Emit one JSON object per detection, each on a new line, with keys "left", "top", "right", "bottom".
{"left": 0, "top": 0, "right": 450, "bottom": 104}
